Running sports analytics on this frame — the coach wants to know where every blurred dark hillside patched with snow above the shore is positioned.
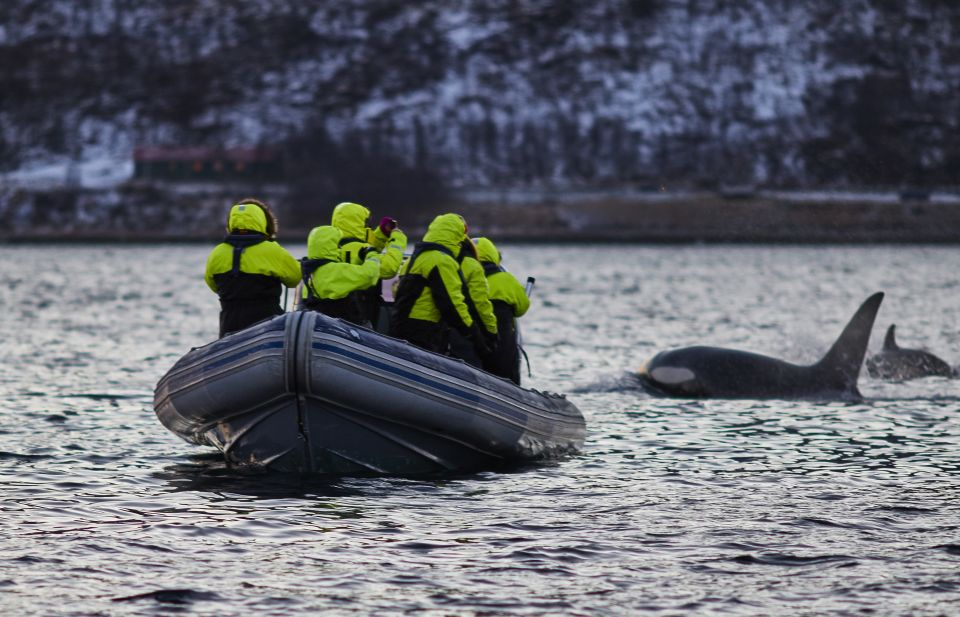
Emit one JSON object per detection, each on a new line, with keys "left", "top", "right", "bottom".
{"left": 0, "top": 0, "right": 960, "bottom": 205}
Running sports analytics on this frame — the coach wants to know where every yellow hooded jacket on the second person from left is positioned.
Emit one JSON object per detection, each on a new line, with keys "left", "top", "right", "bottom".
{"left": 302, "top": 225, "right": 380, "bottom": 300}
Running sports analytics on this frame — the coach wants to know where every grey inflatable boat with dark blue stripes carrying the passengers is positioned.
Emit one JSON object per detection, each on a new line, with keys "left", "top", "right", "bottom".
{"left": 154, "top": 311, "right": 586, "bottom": 475}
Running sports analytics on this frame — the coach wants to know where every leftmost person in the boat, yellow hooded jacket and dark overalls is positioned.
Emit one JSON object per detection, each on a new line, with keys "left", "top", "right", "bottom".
{"left": 204, "top": 199, "right": 300, "bottom": 338}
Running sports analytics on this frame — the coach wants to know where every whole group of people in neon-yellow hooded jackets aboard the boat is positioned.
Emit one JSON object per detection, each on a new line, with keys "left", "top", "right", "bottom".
{"left": 204, "top": 199, "right": 530, "bottom": 384}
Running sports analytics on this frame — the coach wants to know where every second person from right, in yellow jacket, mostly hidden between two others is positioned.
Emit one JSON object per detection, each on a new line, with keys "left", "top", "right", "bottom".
{"left": 450, "top": 238, "right": 497, "bottom": 368}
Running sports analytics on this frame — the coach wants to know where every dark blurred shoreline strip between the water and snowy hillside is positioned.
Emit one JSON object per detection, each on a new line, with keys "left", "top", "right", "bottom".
{"left": 0, "top": 191, "right": 960, "bottom": 245}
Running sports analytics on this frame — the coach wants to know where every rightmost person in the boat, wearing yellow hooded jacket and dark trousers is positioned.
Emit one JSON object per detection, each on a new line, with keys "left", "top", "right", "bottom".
{"left": 474, "top": 238, "right": 530, "bottom": 385}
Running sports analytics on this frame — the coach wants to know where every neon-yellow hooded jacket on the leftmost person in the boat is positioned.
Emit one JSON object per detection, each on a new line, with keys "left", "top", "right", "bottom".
{"left": 204, "top": 204, "right": 300, "bottom": 296}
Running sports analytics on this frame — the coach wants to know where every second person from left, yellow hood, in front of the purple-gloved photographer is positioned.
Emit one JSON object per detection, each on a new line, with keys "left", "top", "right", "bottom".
{"left": 300, "top": 225, "right": 380, "bottom": 327}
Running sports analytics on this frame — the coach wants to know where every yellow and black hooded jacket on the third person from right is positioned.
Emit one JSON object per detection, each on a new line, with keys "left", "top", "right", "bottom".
{"left": 394, "top": 214, "right": 473, "bottom": 336}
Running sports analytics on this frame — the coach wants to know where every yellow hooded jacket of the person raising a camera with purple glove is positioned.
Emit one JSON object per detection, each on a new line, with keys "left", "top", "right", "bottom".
{"left": 330, "top": 202, "right": 407, "bottom": 284}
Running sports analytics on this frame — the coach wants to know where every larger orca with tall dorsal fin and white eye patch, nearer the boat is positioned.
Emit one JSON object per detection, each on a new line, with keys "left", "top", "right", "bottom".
{"left": 639, "top": 292, "right": 883, "bottom": 400}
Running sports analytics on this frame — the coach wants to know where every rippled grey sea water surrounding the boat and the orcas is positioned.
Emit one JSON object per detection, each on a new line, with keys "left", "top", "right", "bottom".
{"left": 0, "top": 245, "right": 960, "bottom": 615}
